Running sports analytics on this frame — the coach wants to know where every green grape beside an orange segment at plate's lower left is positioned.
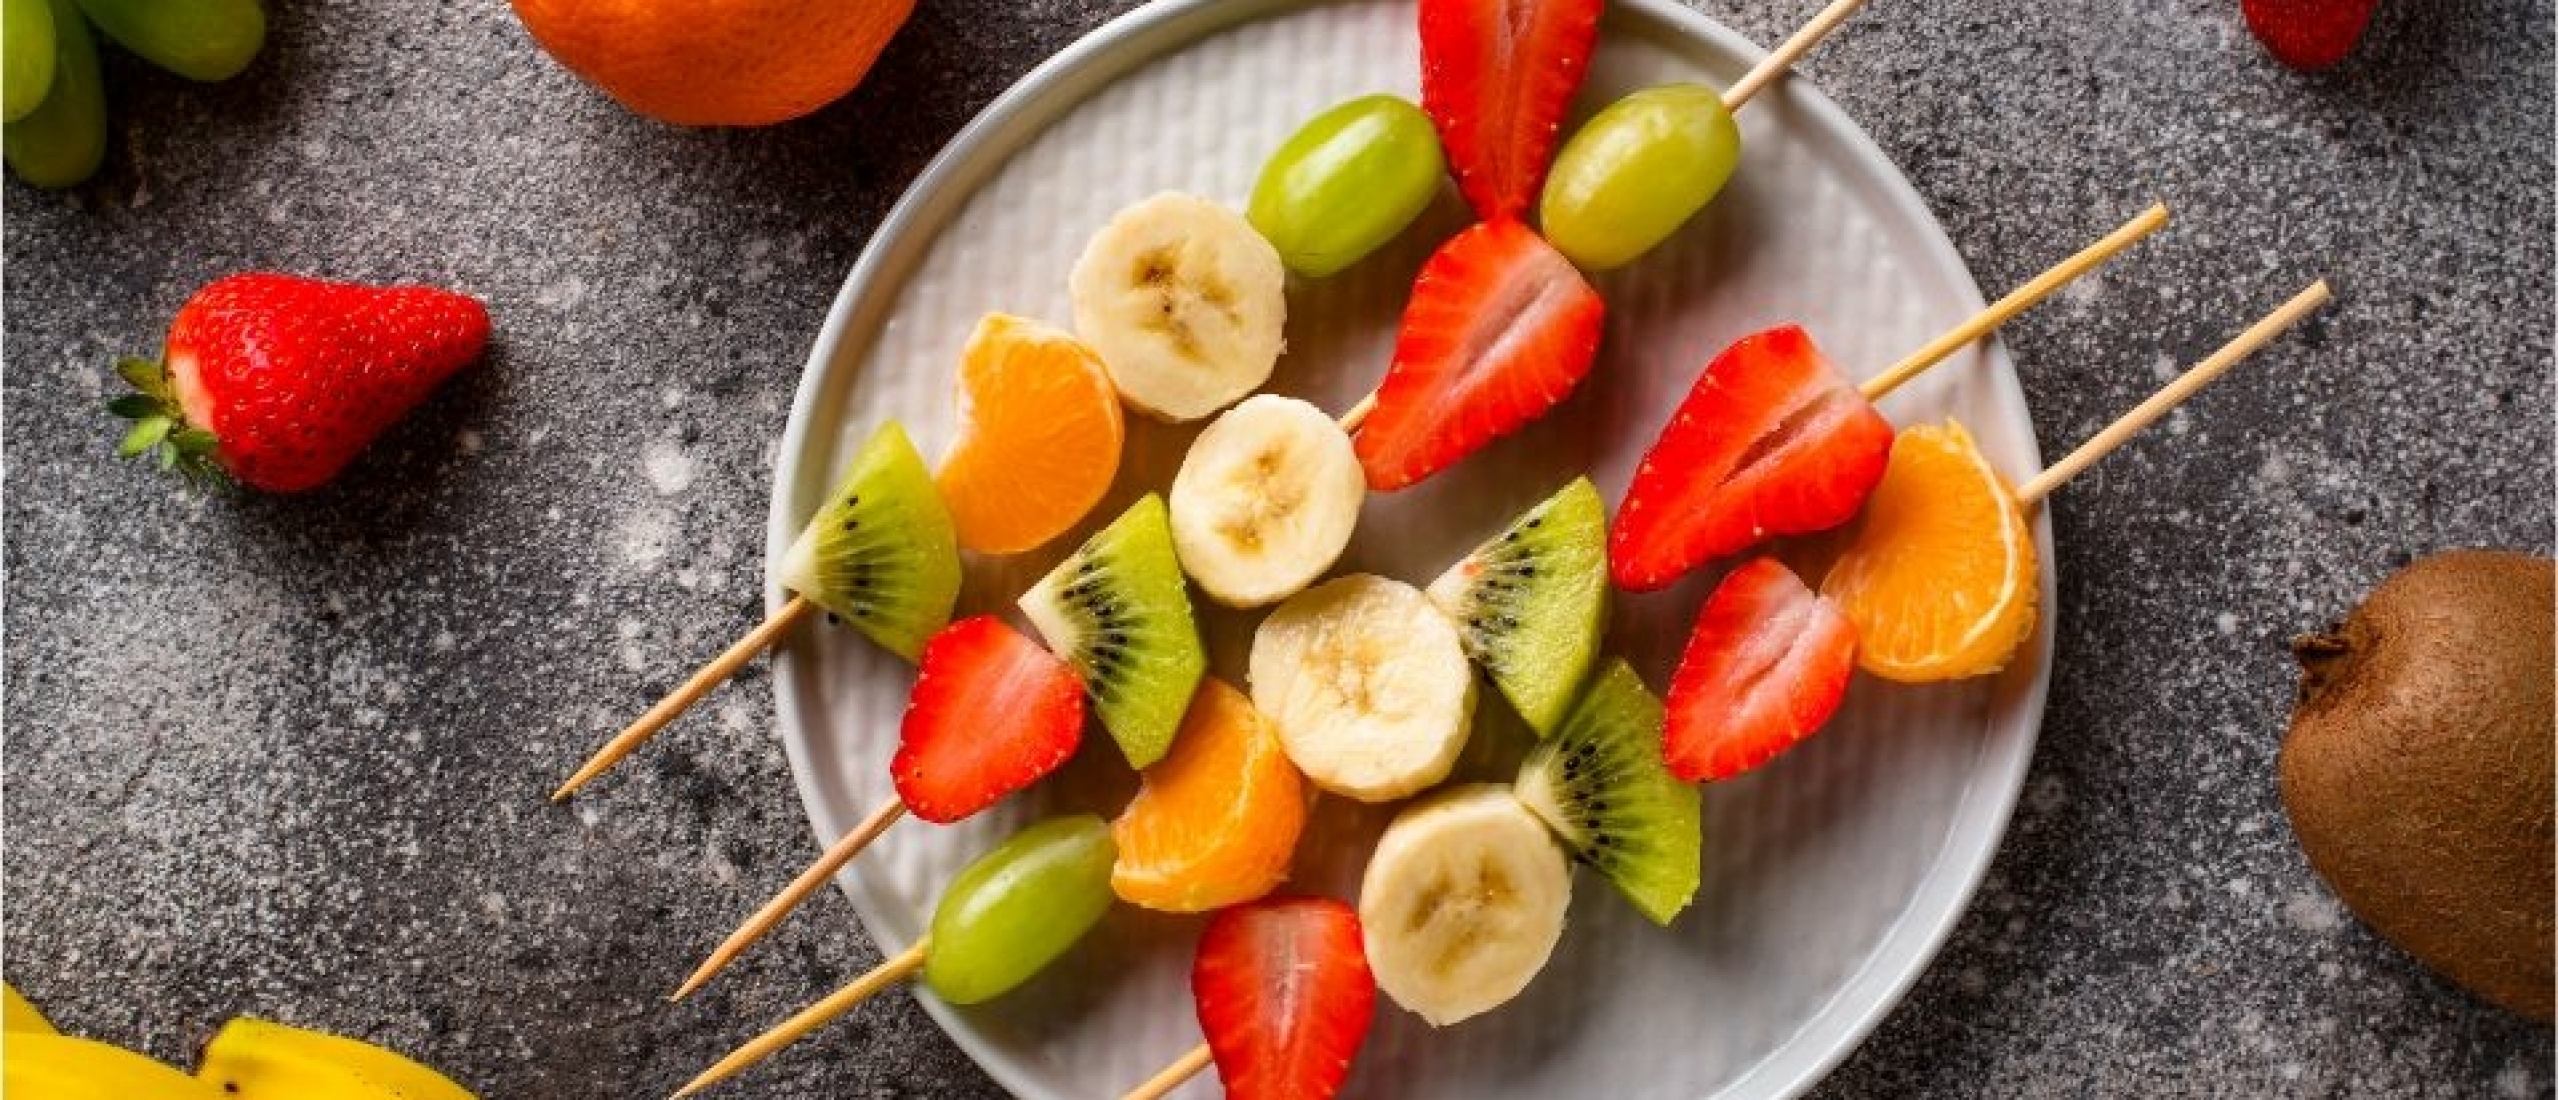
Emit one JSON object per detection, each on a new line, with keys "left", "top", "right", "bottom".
{"left": 923, "top": 813, "right": 1118, "bottom": 1005}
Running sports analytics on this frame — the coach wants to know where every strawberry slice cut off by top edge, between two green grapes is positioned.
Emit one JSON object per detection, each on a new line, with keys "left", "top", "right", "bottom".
{"left": 1422, "top": 0, "right": 1599, "bottom": 220}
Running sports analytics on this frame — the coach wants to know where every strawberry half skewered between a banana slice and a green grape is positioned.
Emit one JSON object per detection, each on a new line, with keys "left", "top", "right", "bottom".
{"left": 1353, "top": 217, "right": 1606, "bottom": 491}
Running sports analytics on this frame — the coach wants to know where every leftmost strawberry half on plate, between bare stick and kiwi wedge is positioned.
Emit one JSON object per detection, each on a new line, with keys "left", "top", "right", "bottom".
{"left": 888, "top": 614, "right": 1085, "bottom": 824}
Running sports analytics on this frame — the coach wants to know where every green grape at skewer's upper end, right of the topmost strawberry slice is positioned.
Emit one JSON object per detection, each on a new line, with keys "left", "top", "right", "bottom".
{"left": 1537, "top": 84, "right": 1742, "bottom": 271}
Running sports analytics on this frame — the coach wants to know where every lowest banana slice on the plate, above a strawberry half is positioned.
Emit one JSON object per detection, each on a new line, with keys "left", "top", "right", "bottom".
{"left": 1358, "top": 783, "right": 1573, "bottom": 1028}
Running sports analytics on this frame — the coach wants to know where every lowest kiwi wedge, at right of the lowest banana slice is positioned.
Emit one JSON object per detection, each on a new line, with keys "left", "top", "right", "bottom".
{"left": 1514, "top": 660, "right": 1704, "bottom": 923}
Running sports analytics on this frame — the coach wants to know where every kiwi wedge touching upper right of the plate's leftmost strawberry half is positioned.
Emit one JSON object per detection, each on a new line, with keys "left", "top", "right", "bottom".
{"left": 1021, "top": 494, "right": 1207, "bottom": 767}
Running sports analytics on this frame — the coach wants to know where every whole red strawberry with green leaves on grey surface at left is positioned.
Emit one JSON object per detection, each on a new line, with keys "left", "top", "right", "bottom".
{"left": 107, "top": 274, "right": 489, "bottom": 494}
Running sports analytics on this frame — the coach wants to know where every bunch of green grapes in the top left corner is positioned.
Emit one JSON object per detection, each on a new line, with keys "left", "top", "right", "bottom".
{"left": 0, "top": 0, "right": 266, "bottom": 187}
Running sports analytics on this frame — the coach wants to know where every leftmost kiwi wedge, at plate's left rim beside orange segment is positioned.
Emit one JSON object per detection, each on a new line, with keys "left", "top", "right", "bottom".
{"left": 780, "top": 420, "right": 959, "bottom": 660}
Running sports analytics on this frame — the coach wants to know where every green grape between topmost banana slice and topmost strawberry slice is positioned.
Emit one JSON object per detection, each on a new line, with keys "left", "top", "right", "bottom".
{"left": 1246, "top": 95, "right": 1443, "bottom": 279}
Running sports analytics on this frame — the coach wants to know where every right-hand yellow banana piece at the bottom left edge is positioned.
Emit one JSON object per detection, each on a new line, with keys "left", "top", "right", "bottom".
{"left": 199, "top": 1016, "right": 473, "bottom": 1100}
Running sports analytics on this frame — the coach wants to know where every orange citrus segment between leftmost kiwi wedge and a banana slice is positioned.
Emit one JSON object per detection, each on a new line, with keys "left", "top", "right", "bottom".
{"left": 936, "top": 312, "right": 1123, "bottom": 553}
